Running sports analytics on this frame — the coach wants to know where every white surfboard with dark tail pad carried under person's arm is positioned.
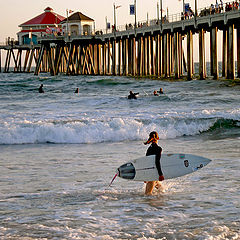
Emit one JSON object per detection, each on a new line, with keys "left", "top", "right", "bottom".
{"left": 117, "top": 153, "right": 211, "bottom": 181}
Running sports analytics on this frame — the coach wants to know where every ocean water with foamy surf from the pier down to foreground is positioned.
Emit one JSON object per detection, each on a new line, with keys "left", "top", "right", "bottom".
{"left": 0, "top": 73, "right": 240, "bottom": 240}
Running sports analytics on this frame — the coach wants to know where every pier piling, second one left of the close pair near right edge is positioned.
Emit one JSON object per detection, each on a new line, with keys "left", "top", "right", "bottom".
{"left": 199, "top": 29, "right": 206, "bottom": 79}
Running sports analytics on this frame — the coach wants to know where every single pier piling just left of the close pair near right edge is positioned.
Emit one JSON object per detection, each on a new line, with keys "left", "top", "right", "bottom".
{"left": 211, "top": 27, "right": 219, "bottom": 79}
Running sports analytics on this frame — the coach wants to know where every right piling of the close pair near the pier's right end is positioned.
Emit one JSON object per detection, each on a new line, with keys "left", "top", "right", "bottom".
{"left": 227, "top": 24, "right": 235, "bottom": 79}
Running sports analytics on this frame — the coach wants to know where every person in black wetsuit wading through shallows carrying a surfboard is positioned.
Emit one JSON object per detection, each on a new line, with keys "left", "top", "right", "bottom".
{"left": 144, "top": 131, "right": 164, "bottom": 195}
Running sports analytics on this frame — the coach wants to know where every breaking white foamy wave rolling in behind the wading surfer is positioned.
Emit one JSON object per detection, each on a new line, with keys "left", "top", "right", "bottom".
{"left": 0, "top": 116, "right": 240, "bottom": 144}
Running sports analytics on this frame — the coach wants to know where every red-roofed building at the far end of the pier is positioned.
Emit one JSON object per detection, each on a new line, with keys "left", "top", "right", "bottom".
{"left": 17, "top": 7, "right": 65, "bottom": 45}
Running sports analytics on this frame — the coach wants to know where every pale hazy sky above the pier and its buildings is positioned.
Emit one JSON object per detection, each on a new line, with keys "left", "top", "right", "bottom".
{"left": 0, "top": 0, "right": 215, "bottom": 42}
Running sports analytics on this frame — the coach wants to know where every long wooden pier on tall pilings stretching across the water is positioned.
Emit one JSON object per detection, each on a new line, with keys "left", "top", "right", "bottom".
{"left": 0, "top": 4, "right": 240, "bottom": 80}
